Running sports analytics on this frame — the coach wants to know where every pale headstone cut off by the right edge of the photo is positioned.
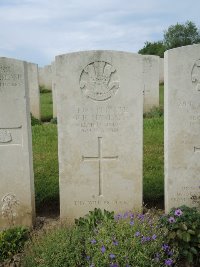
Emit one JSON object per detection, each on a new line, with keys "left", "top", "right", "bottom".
{"left": 165, "top": 45, "right": 200, "bottom": 214}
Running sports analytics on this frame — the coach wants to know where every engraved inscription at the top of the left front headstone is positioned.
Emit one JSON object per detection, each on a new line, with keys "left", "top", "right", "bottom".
{"left": 0, "top": 65, "right": 23, "bottom": 87}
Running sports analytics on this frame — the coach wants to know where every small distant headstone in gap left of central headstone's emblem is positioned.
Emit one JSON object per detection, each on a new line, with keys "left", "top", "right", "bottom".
{"left": 38, "top": 65, "right": 52, "bottom": 90}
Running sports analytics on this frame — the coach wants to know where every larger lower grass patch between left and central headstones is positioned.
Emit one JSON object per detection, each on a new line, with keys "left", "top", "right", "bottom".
{"left": 32, "top": 124, "right": 59, "bottom": 213}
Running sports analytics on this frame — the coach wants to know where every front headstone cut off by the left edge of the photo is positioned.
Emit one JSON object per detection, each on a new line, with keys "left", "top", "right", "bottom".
{"left": 0, "top": 58, "right": 35, "bottom": 229}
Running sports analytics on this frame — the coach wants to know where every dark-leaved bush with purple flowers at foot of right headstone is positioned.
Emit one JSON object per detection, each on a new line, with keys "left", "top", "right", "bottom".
{"left": 161, "top": 206, "right": 200, "bottom": 266}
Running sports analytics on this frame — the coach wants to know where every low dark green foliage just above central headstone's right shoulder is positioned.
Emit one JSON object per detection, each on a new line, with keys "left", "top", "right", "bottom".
{"left": 138, "top": 41, "right": 166, "bottom": 58}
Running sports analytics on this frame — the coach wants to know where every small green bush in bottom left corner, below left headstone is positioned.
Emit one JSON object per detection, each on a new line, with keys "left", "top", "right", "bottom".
{"left": 0, "top": 227, "right": 29, "bottom": 261}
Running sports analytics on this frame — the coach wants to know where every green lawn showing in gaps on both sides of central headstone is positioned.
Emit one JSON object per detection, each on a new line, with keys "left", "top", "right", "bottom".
{"left": 32, "top": 85, "right": 164, "bottom": 214}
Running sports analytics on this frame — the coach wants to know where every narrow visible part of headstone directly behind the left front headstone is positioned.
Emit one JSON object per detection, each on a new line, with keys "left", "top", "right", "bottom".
{"left": 28, "top": 63, "right": 41, "bottom": 120}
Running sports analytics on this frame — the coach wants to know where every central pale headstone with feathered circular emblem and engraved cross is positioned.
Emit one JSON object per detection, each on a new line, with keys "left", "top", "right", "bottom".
{"left": 56, "top": 51, "right": 143, "bottom": 221}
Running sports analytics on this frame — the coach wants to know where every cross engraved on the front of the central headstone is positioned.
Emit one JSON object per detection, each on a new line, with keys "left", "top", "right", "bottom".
{"left": 82, "top": 137, "right": 118, "bottom": 196}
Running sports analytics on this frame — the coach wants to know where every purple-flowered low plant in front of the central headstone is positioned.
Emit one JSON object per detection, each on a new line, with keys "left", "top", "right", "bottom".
{"left": 85, "top": 212, "right": 177, "bottom": 267}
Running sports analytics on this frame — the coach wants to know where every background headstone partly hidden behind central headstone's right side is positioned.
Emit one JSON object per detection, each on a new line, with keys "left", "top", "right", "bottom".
{"left": 143, "top": 56, "right": 159, "bottom": 112}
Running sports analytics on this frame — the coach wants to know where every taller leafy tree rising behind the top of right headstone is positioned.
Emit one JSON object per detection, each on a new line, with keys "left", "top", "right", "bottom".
{"left": 163, "top": 21, "right": 200, "bottom": 49}
